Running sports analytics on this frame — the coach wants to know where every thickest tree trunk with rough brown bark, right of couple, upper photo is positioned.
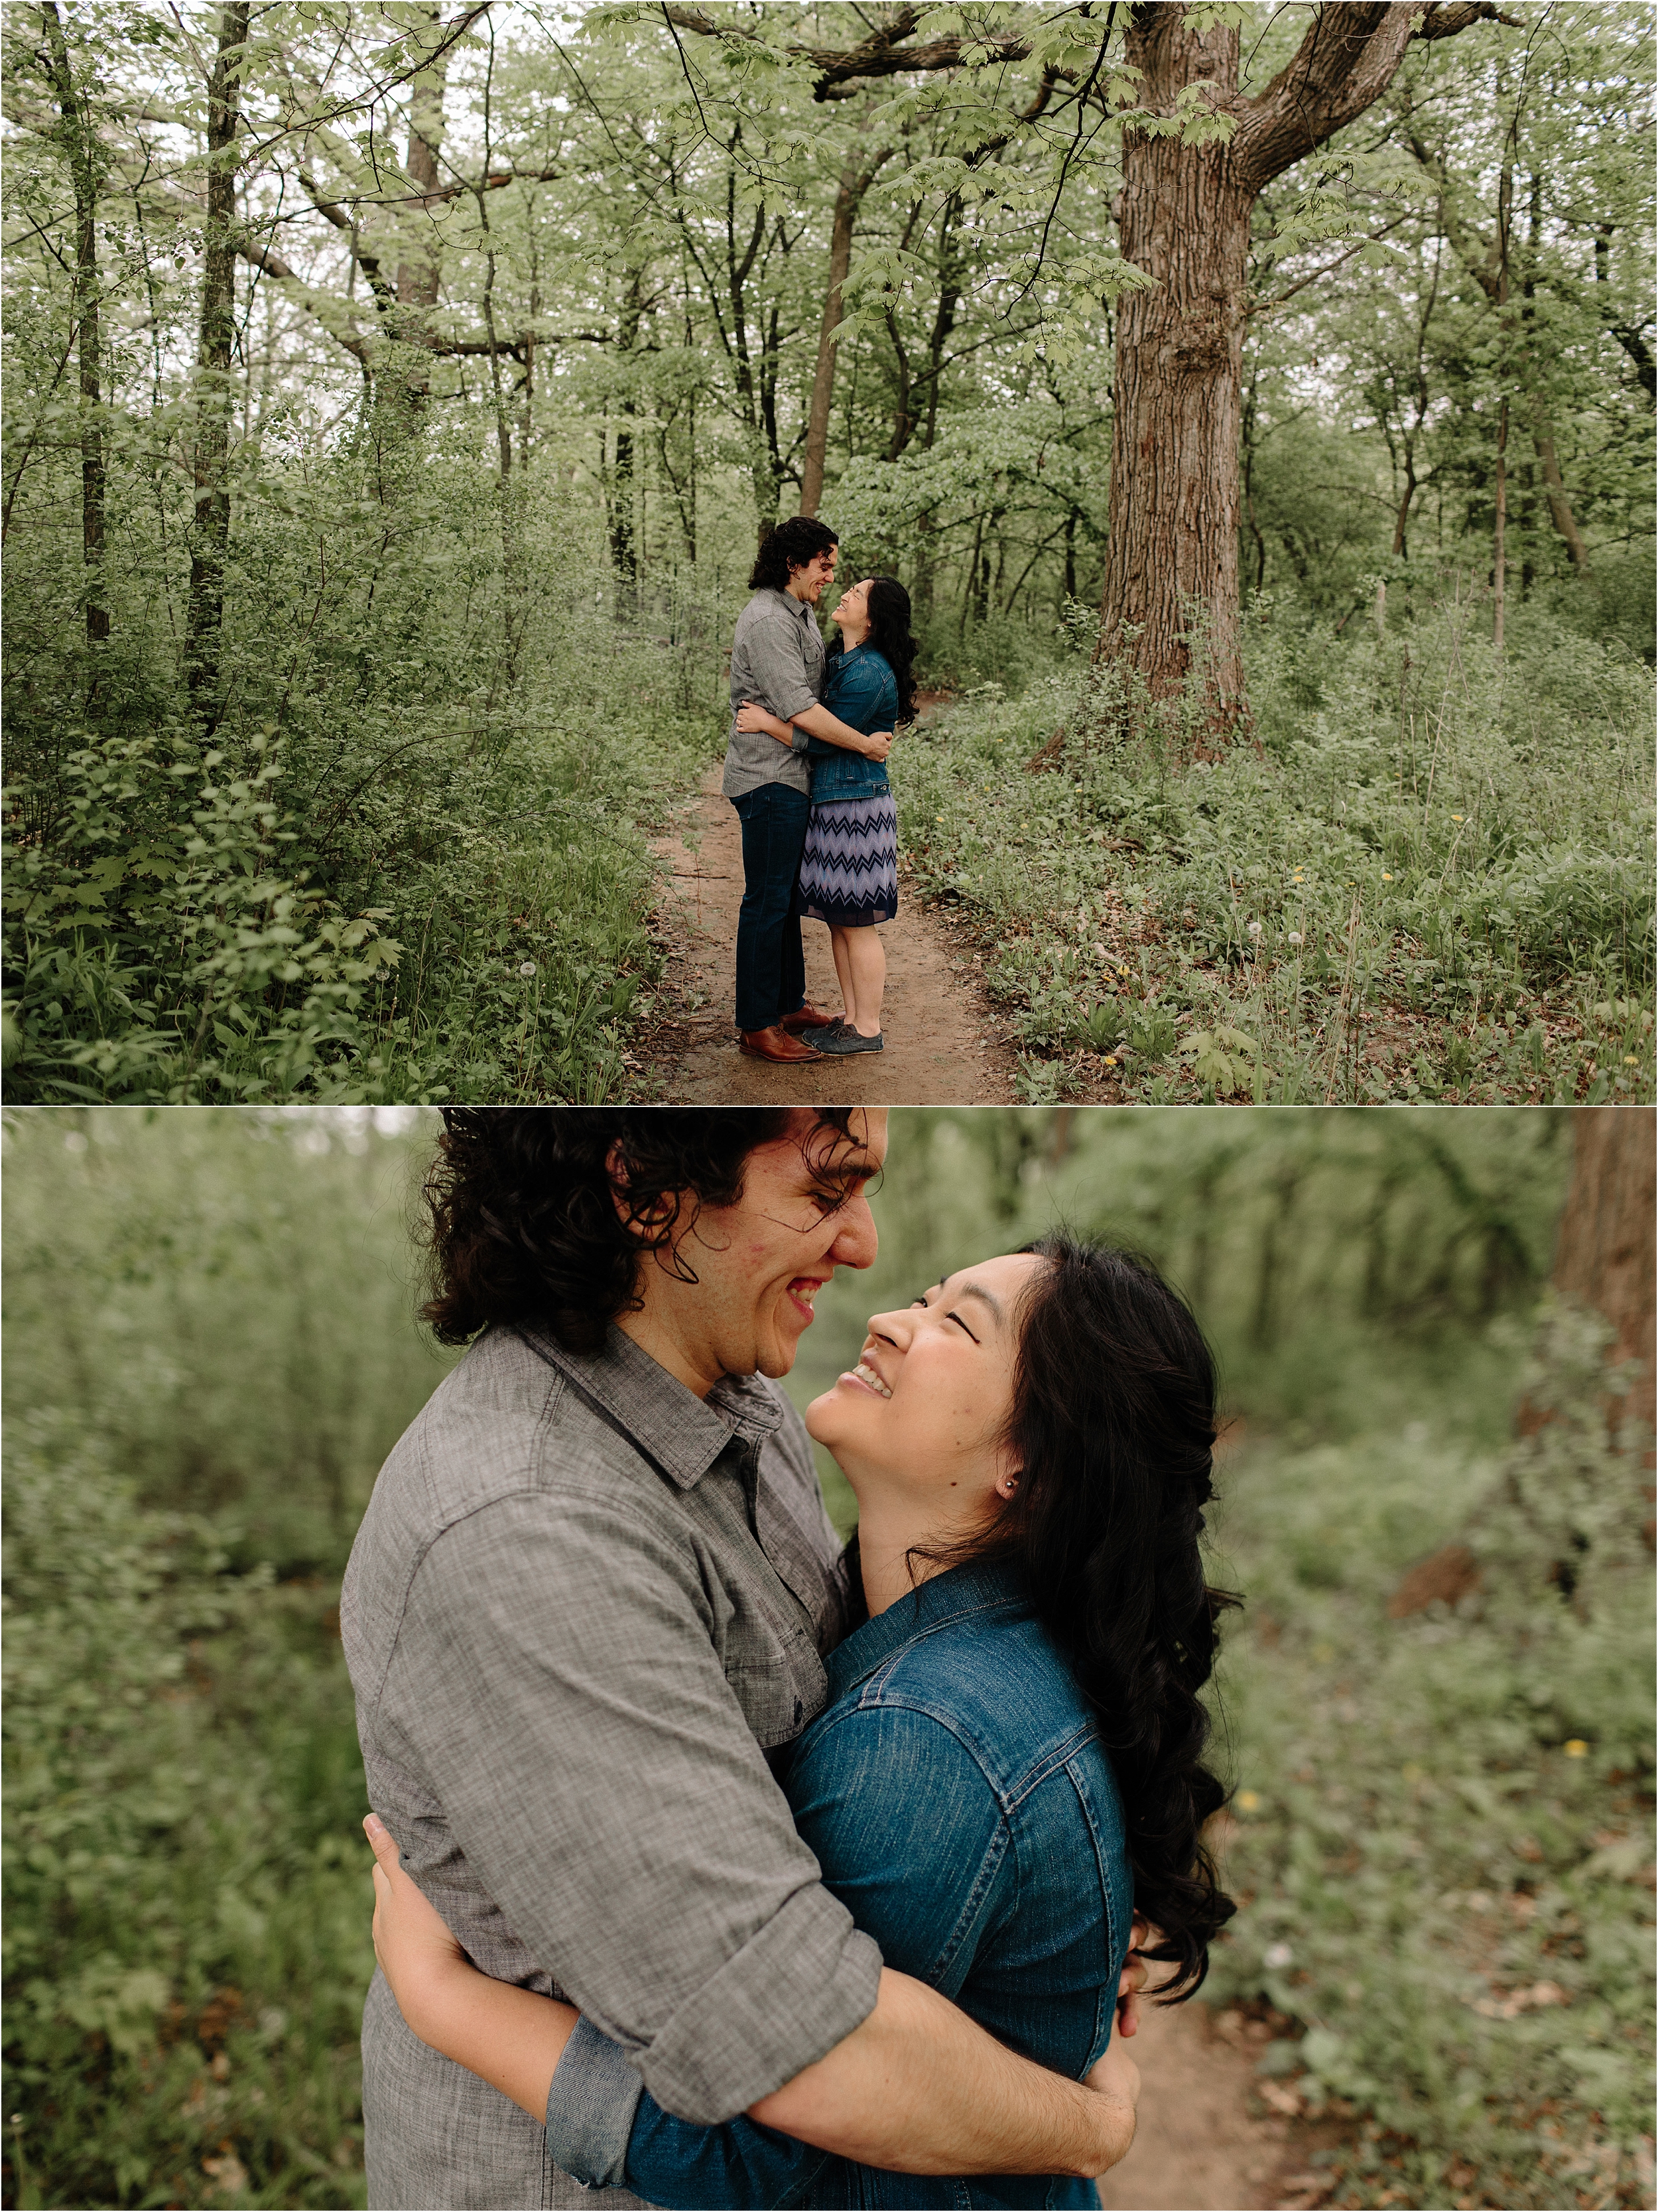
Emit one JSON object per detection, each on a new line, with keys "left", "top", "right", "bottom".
{"left": 1101, "top": 5, "right": 1253, "bottom": 726}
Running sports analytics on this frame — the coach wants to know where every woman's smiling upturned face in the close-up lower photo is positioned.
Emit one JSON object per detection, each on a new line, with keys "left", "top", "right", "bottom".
{"left": 807, "top": 1252, "right": 1048, "bottom": 1522}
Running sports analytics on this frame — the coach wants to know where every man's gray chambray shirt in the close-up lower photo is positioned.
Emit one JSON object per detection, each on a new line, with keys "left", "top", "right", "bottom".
{"left": 340, "top": 1327, "right": 880, "bottom": 2207}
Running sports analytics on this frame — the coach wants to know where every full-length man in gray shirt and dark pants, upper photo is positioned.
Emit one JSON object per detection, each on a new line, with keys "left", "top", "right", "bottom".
{"left": 721, "top": 515, "right": 891, "bottom": 1066}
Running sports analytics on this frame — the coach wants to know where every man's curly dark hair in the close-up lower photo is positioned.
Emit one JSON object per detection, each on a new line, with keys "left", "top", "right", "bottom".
{"left": 420, "top": 1106, "right": 860, "bottom": 1352}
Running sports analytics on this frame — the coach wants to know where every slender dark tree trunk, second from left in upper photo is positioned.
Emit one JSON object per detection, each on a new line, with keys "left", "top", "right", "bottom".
{"left": 184, "top": 0, "right": 247, "bottom": 719}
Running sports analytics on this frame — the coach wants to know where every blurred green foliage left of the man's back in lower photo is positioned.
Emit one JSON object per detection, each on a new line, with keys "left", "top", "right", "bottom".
{"left": 5, "top": 1110, "right": 449, "bottom": 2207}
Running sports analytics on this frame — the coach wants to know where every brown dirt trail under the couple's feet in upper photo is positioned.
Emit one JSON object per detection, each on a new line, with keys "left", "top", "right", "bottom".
{"left": 648, "top": 767, "right": 1015, "bottom": 1106}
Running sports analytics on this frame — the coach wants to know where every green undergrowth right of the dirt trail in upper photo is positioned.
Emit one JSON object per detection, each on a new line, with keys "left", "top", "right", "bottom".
{"left": 893, "top": 602, "right": 1653, "bottom": 1104}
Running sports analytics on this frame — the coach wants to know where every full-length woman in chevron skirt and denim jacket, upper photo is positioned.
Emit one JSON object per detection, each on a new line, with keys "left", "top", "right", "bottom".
{"left": 736, "top": 575, "right": 915, "bottom": 1053}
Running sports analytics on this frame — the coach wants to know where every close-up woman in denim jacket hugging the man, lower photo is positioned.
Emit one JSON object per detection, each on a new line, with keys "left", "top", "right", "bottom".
{"left": 369, "top": 1236, "right": 1236, "bottom": 2207}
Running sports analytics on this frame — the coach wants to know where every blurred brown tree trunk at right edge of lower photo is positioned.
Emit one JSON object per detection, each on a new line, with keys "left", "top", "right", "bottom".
{"left": 1554, "top": 1106, "right": 1658, "bottom": 1427}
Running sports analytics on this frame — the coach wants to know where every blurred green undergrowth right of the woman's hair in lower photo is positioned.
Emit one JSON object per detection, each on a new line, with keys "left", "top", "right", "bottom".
{"left": 1207, "top": 1312, "right": 1653, "bottom": 2207}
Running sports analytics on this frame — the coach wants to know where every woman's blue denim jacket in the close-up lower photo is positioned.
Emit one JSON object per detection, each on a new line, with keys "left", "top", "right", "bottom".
{"left": 625, "top": 1566, "right": 1134, "bottom": 2207}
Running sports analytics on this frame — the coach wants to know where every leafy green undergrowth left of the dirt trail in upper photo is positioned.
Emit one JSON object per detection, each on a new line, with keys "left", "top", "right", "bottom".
{"left": 5, "top": 434, "right": 716, "bottom": 1104}
